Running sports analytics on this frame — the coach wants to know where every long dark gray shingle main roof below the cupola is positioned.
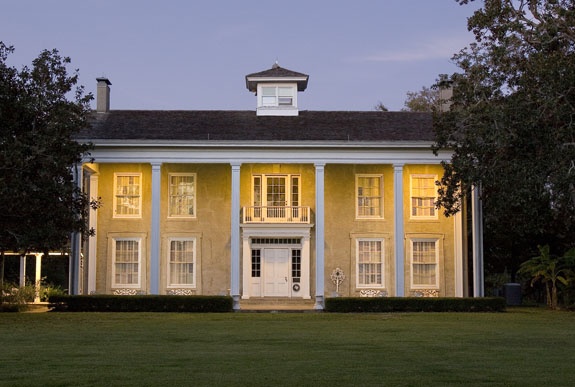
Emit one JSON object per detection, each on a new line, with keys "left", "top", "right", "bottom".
{"left": 77, "top": 110, "right": 433, "bottom": 142}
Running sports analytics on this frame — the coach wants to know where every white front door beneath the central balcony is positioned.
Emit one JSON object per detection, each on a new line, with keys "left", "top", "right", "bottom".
{"left": 263, "top": 248, "right": 289, "bottom": 297}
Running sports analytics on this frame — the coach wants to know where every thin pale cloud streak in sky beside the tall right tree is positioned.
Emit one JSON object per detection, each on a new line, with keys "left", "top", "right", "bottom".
{"left": 354, "top": 37, "right": 471, "bottom": 63}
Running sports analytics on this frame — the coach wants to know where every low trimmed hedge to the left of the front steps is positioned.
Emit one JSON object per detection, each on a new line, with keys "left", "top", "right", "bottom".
{"left": 49, "top": 294, "right": 233, "bottom": 313}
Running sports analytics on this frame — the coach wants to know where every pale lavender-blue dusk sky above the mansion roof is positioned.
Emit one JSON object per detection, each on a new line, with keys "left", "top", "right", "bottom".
{"left": 0, "top": 0, "right": 482, "bottom": 111}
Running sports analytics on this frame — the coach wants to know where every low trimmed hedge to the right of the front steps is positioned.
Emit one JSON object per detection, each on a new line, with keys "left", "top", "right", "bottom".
{"left": 325, "top": 297, "right": 506, "bottom": 313}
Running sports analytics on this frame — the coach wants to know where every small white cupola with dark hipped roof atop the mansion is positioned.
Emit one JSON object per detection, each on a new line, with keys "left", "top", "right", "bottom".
{"left": 246, "top": 62, "right": 309, "bottom": 116}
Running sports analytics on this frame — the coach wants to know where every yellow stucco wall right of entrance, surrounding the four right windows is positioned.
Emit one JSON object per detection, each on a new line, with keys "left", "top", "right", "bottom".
{"left": 324, "top": 165, "right": 455, "bottom": 296}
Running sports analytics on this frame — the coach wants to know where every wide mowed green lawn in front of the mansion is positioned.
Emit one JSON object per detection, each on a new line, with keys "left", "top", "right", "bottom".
{"left": 0, "top": 308, "right": 575, "bottom": 386}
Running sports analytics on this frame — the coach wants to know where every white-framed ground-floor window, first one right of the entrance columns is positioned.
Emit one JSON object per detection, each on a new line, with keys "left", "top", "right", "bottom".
{"left": 356, "top": 238, "right": 385, "bottom": 288}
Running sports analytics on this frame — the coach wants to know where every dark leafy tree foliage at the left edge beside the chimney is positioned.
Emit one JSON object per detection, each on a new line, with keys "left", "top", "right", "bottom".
{"left": 0, "top": 42, "right": 92, "bottom": 253}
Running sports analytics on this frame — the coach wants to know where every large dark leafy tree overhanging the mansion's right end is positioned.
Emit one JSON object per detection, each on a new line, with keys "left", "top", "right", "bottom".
{"left": 434, "top": 0, "right": 575, "bottom": 271}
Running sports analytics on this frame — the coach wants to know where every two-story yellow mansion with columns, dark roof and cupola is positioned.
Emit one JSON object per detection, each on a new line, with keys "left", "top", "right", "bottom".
{"left": 73, "top": 64, "right": 480, "bottom": 309}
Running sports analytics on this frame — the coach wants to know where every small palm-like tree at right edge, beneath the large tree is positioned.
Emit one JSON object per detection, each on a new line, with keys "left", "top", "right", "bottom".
{"left": 519, "top": 245, "right": 575, "bottom": 309}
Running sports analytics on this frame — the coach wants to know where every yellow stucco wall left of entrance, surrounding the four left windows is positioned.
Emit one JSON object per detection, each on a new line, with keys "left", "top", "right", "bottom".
{"left": 96, "top": 164, "right": 231, "bottom": 294}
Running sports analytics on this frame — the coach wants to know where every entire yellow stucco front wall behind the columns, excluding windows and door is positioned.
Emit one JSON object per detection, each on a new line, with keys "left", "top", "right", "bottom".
{"left": 90, "top": 164, "right": 455, "bottom": 297}
